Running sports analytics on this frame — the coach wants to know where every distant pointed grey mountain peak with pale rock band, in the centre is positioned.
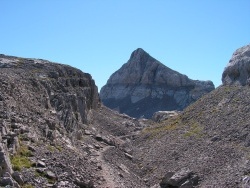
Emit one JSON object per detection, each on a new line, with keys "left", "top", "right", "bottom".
{"left": 100, "top": 48, "right": 214, "bottom": 118}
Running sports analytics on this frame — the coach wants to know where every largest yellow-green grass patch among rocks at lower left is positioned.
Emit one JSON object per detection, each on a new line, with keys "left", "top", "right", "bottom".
{"left": 10, "top": 143, "right": 32, "bottom": 171}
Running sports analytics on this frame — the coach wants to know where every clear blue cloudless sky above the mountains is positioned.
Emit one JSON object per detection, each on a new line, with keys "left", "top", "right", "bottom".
{"left": 0, "top": 0, "right": 250, "bottom": 89}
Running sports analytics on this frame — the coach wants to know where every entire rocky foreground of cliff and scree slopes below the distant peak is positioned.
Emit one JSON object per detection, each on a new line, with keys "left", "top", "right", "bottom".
{"left": 0, "top": 43, "right": 250, "bottom": 188}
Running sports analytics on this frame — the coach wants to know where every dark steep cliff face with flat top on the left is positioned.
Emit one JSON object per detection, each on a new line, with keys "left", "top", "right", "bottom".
{"left": 0, "top": 55, "right": 99, "bottom": 129}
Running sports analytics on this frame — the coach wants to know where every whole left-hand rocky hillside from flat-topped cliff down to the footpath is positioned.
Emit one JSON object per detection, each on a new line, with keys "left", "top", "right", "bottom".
{"left": 0, "top": 55, "right": 147, "bottom": 188}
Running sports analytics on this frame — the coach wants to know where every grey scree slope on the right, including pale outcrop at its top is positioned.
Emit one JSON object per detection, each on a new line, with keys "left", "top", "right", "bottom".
{"left": 130, "top": 46, "right": 250, "bottom": 188}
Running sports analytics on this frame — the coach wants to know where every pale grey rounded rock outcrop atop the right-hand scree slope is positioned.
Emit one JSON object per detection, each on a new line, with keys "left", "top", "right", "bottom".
{"left": 222, "top": 45, "right": 250, "bottom": 86}
